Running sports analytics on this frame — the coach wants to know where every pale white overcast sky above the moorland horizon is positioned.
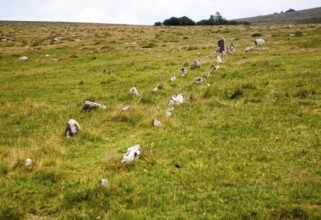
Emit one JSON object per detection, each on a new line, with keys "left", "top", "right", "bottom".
{"left": 0, "top": 0, "right": 321, "bottom": 25}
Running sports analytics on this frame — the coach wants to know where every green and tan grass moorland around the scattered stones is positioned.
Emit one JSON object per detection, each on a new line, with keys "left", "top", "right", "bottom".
{"left": 0, "top": 22, "right": 321, "bottom": 219}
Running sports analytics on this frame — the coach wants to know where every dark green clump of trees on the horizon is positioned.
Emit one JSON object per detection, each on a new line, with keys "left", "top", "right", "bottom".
{"left": 154, "top": 12, "right": 250, "bottom": 26}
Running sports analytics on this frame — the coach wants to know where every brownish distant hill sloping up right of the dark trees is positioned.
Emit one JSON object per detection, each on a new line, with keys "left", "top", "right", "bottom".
{"left": 234, "top": 7, "right": 321, "bottom": 24}
